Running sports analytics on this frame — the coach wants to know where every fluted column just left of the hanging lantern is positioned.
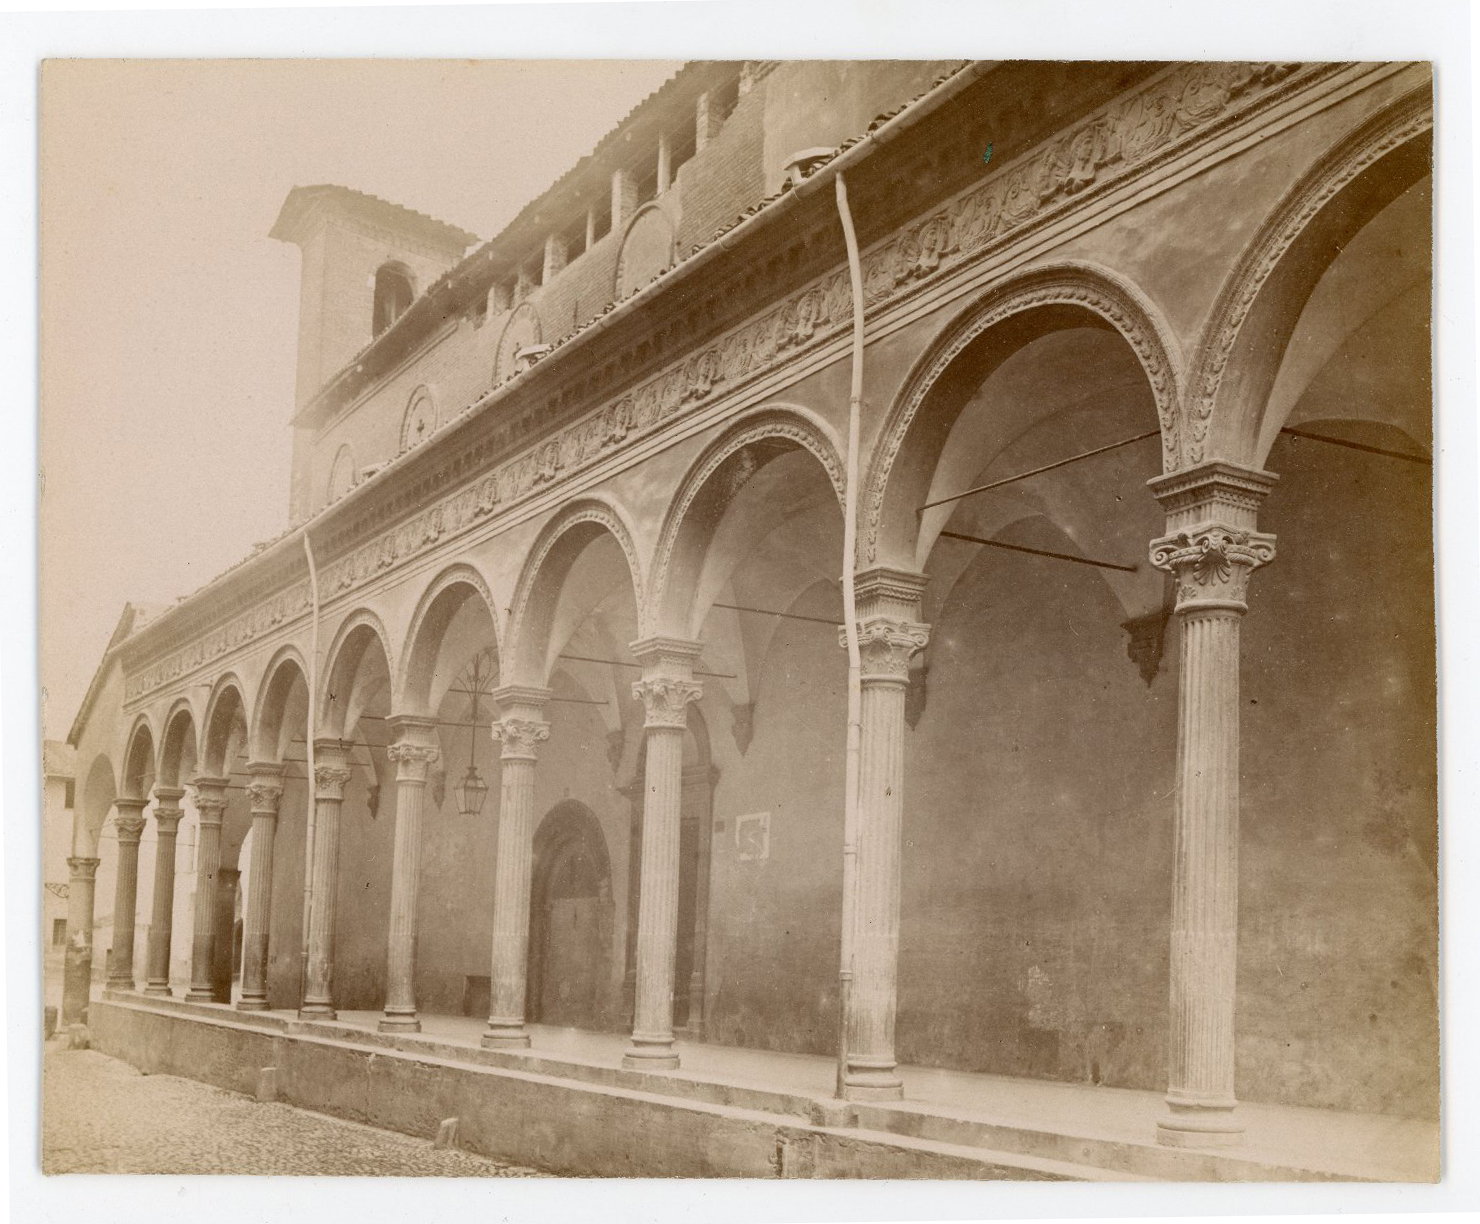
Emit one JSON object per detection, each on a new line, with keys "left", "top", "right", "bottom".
{"left": 379, "top": 716, "right": 435, "bottom": 1033}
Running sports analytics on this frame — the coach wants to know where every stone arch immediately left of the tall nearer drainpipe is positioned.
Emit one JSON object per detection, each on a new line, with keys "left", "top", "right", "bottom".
{"left": 647, "top": 404, "right": 845, "bottom": 636}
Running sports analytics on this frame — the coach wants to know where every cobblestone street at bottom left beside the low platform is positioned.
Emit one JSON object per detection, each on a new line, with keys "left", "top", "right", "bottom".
{"left": 41, "top": 1043, "right": 542, "bottom": 1177}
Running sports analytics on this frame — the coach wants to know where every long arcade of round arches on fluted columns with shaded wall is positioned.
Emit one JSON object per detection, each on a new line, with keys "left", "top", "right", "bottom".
{"left": 63, "top": 66, "right": 1439, "bottom": 1146}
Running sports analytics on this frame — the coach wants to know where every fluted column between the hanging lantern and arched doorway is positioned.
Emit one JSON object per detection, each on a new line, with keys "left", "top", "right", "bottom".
{"left": 482, "top": 685, "right": 551, "bottom": 1049}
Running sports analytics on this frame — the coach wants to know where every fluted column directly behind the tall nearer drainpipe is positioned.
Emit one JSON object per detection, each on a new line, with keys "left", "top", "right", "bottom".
{"left": 839, "top": 567, "right": 929, "bottom": 1101}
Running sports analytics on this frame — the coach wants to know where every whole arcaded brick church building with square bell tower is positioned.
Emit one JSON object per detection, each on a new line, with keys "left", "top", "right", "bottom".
{"left": 57, "top": 62, "right": 1439, "bottom": 1178}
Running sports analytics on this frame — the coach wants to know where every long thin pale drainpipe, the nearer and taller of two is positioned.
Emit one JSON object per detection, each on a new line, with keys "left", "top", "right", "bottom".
{"left": 835, "top": 175, "right": 863, "bottom": 1097}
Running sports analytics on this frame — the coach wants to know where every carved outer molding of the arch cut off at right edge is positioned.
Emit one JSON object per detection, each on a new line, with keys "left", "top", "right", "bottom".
{"left": 1183, "top": 89, "right": 1434, "bottom": 465}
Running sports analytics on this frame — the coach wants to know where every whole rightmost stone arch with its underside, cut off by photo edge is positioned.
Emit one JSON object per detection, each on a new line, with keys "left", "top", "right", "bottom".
{"left": 1180, "top": 89, "right": 1434, "bottom": 466}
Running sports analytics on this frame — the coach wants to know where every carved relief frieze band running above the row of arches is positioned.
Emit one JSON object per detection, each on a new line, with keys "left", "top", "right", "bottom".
{"left": 124, "top": 64, "right": 1302, "bottom": 702}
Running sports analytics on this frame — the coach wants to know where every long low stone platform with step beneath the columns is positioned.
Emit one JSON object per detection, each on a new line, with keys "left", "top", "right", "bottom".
{"left": 90, "top": 990, "right": 1439, "bottom": 1181}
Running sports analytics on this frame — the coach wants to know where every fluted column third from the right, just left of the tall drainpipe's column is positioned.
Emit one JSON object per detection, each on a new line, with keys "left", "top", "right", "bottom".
{"left": 622, "top": 638, "right": 703, "bottom": 1070}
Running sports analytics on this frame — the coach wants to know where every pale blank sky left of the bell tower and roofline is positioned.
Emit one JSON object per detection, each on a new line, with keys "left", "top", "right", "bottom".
{"left": 40, "top": 59, "right": 679, "bottom": 739}
